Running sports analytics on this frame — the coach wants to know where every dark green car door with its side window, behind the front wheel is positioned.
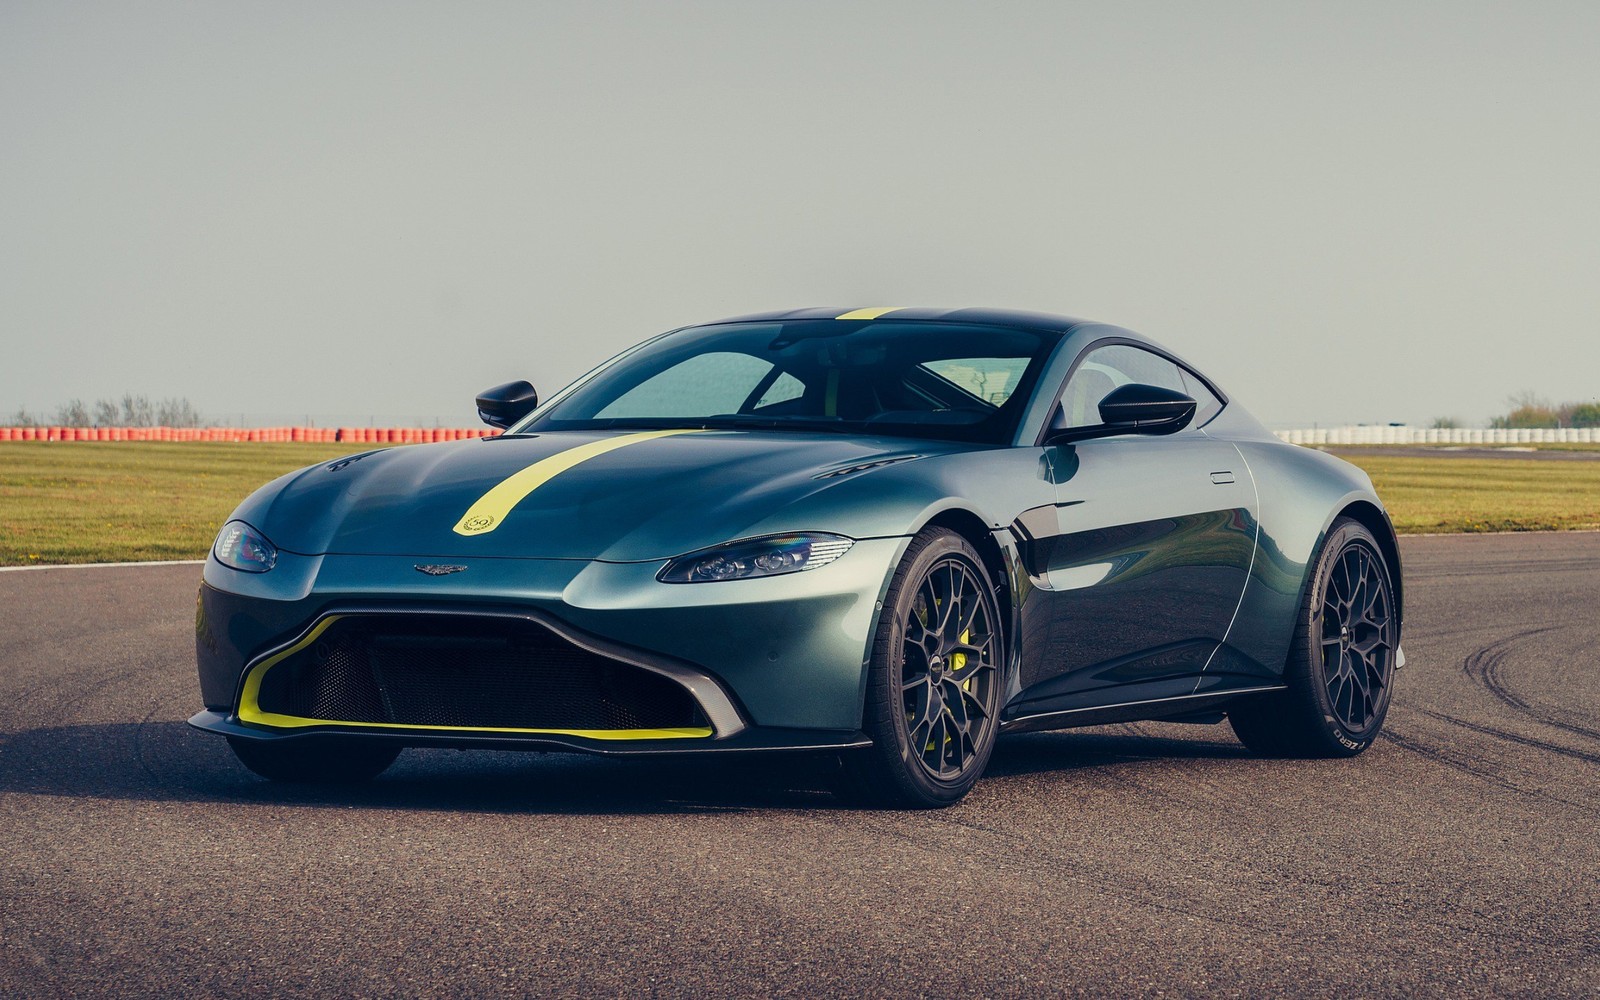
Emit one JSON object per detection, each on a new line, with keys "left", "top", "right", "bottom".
{"left": 1013, "top": 342, "right": 1256, "bottom": 714}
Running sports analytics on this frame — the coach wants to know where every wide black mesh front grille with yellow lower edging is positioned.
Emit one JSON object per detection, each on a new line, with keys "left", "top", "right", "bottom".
{"left": 258, "top": 616, "right": 709, "bottom": 730}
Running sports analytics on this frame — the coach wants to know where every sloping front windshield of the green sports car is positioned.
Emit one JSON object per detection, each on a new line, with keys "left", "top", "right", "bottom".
{"left": 510, "top": 320, "right": 1059, "bottom": 445}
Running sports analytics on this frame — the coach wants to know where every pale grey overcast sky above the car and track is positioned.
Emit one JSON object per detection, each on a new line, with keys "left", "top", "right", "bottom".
{"left": 0, "top": 0, "right": 1600, "bottom": 426}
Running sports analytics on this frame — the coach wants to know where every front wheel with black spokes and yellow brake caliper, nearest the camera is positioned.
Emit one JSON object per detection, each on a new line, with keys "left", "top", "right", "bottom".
{"left": 837, "top": 528, "right": 1005, "bottom": 810}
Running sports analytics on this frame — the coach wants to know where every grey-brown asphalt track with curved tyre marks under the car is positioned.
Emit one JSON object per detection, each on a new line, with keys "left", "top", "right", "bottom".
{"left": 0, "top": 534, "right": 1600, "bottom": 997}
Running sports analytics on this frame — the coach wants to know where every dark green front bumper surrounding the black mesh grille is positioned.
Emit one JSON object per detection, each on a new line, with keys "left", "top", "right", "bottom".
{"left": 190, "top": 538, "right": 907, "bottom": 742}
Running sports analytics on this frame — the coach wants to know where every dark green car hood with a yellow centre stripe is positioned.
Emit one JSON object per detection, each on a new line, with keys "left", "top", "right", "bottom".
{"left": 235, "top": 430, "right": 965, "bottom": 562}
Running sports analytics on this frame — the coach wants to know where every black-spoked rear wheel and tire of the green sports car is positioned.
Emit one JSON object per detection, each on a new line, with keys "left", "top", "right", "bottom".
{"left": 1229, "top": 518, "right": 1400, "bottom": 757}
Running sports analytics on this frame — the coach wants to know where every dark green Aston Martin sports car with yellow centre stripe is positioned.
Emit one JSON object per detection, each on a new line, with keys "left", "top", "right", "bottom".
{"left": 190, "top": 309, "right": 1403, "bottom": 806}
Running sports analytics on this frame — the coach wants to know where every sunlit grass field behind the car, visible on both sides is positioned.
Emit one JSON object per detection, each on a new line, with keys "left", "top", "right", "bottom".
{"left": 0, "top": 442, "right": 1600, "bottom": 566}
